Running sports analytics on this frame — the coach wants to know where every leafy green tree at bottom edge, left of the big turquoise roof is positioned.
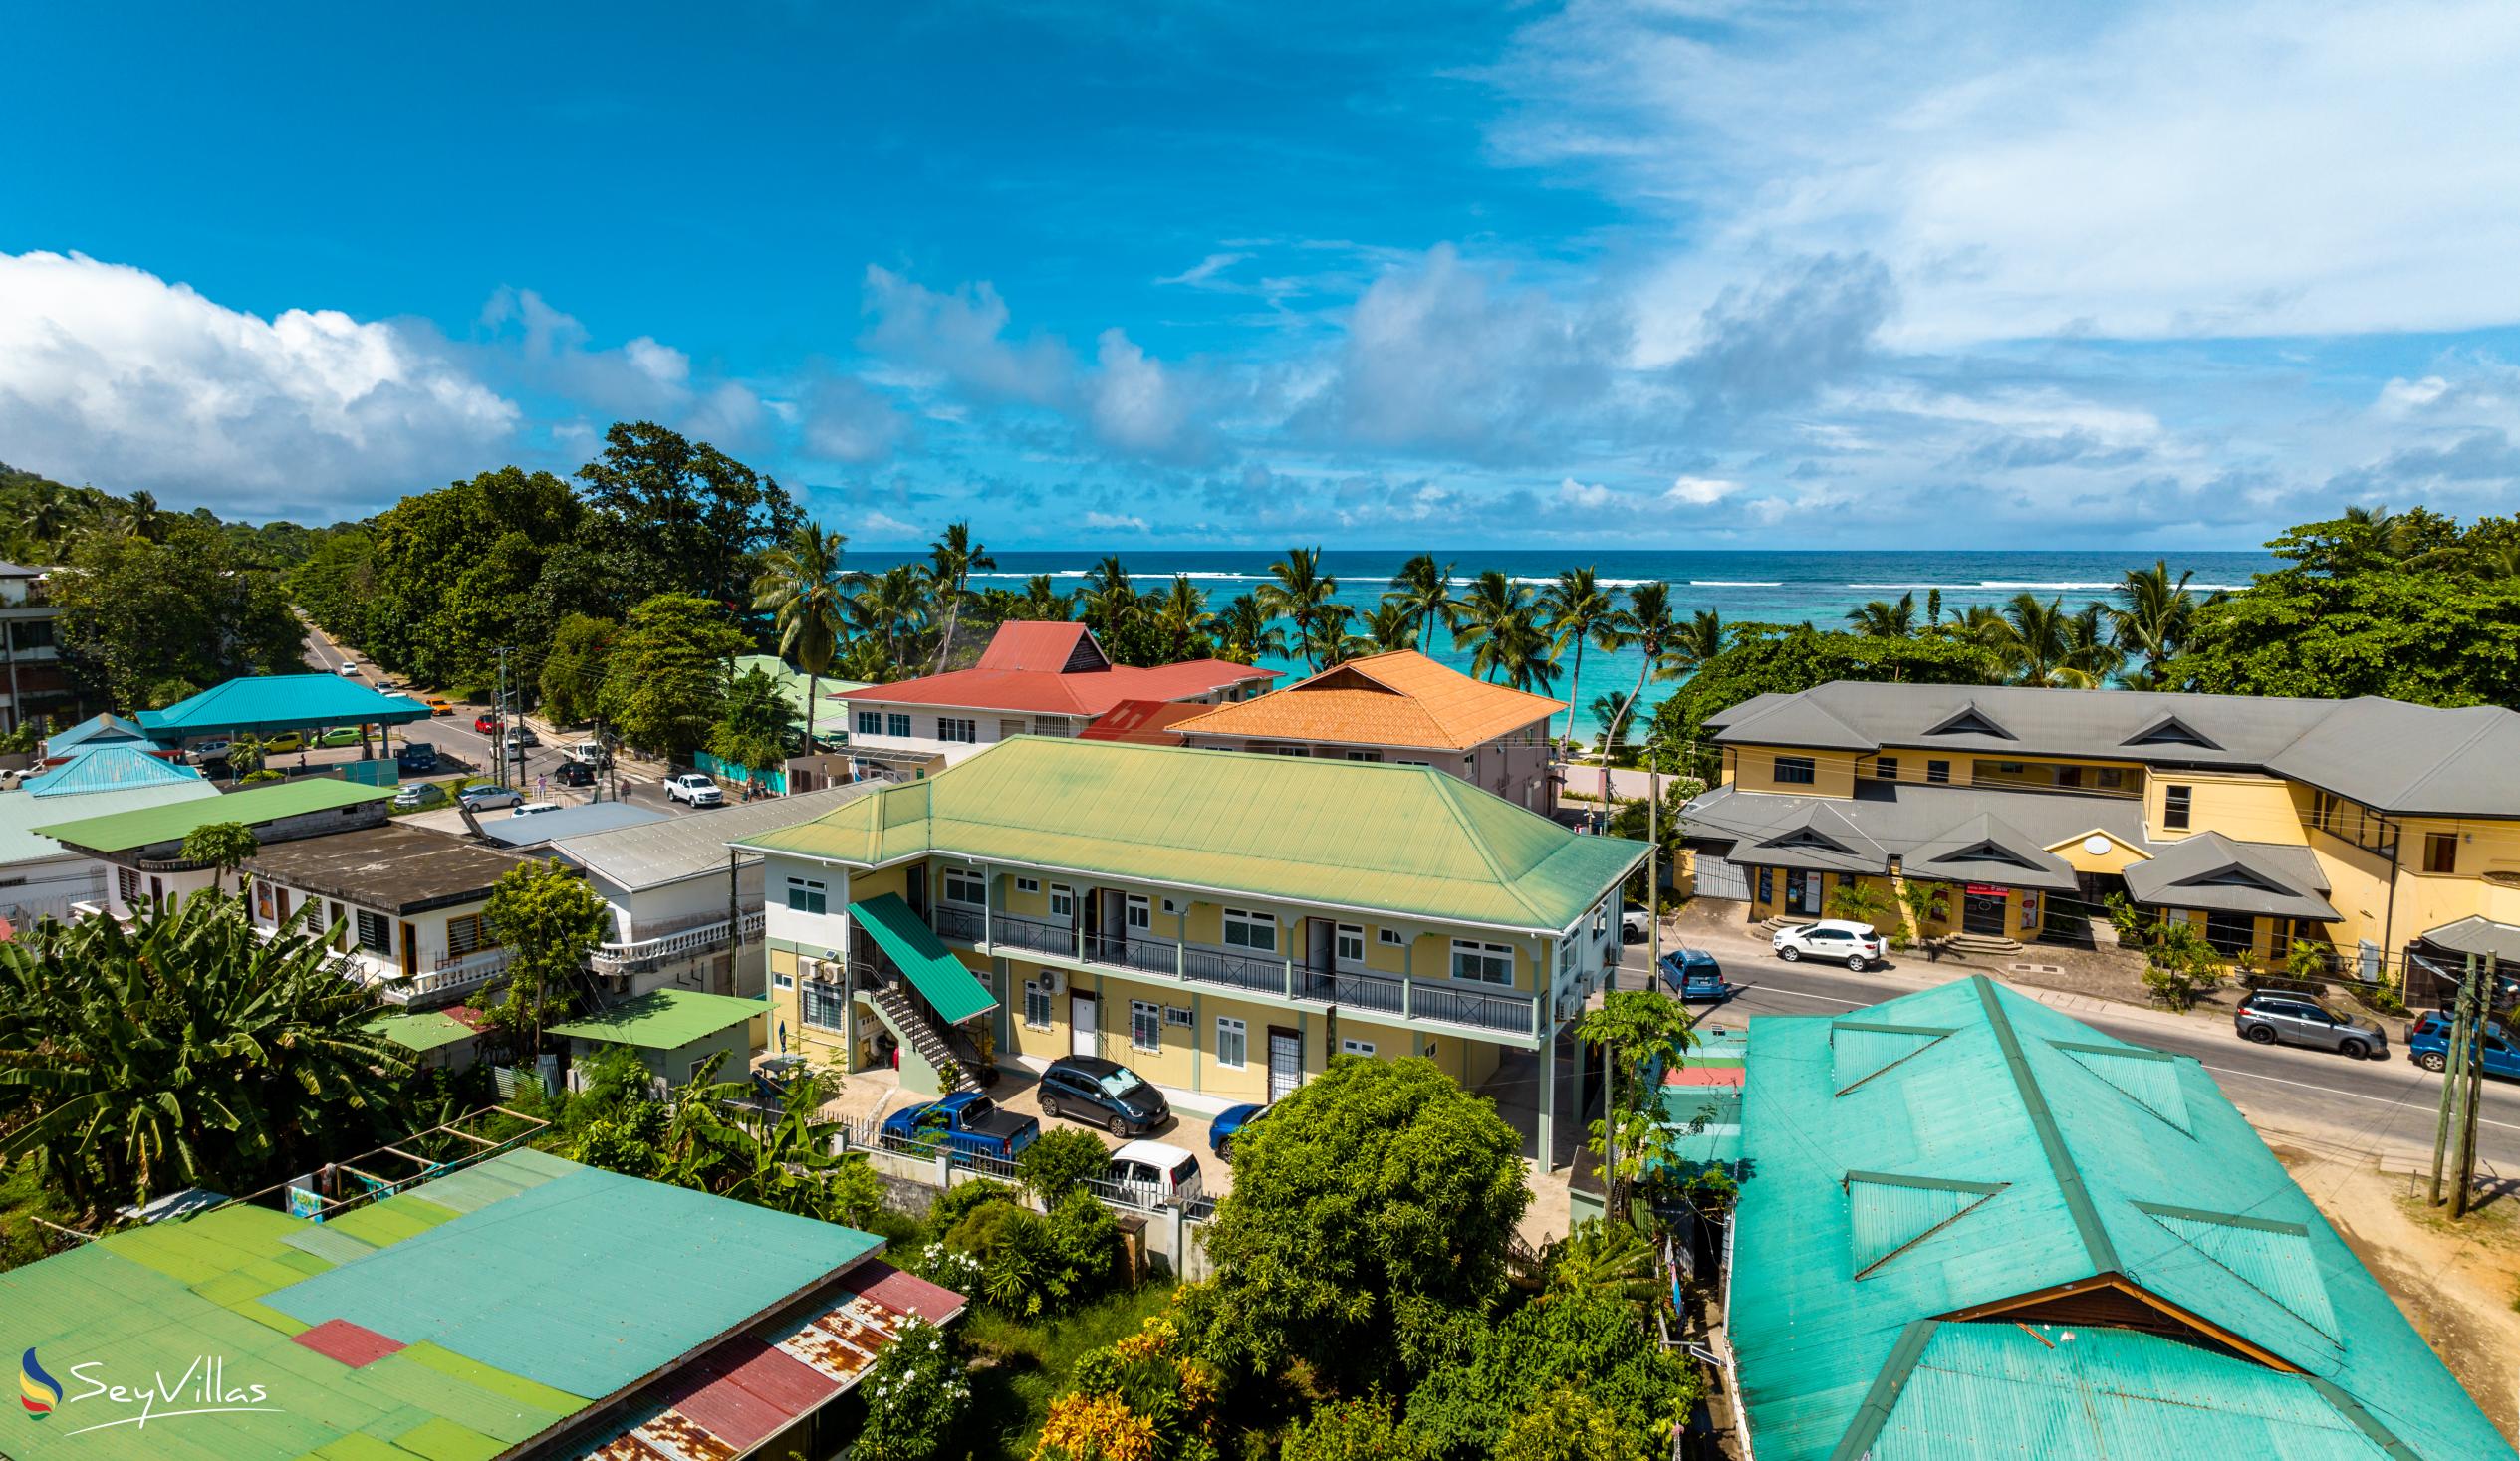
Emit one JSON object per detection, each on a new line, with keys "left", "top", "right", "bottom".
{"left": 1408, "top": 1287, "right": 1698, "bottom": 1461}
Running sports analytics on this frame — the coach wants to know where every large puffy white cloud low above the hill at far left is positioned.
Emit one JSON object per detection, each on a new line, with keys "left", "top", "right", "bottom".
{"left": 0, "top": 252, "right": 522, "bottom": 519}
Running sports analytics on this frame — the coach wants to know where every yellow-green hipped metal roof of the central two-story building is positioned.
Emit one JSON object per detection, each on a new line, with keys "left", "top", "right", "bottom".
{"left": 738, "top": 736, "right": 1645, "bottom": 932}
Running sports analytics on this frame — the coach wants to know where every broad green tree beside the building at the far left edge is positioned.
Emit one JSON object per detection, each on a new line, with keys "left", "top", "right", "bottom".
{"left": 51, "top": 519, "right": 305, "bottom": 708}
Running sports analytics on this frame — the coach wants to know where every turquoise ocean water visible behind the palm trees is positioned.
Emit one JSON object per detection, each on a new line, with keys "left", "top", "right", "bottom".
{"left": 850, "top": 549, "right": 2278, "bottom": 736}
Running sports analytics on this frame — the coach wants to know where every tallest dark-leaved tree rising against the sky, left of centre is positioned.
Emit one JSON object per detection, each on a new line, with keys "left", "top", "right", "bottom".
{"left": 577, "top": 420, "right": 799, "bottom": 608}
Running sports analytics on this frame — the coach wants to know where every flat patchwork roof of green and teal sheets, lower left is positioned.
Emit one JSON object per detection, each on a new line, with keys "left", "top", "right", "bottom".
{"left": 0, "top": 1151, "right": 882, "bottom": 1461}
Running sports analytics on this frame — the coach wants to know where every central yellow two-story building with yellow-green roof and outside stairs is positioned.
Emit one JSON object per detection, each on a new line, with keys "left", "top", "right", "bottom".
{"left": 741, "top": 736, "right": 1645, "bottom": 1151}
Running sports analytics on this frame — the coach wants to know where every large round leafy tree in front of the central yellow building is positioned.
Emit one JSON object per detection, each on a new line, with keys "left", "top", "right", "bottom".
{"left": 1202, "top": 1058, "right": 1530, "bottom": 1393}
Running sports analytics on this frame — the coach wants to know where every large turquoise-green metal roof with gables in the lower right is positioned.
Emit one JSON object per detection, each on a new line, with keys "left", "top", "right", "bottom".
{"left": 1731, "top": 977, "right": 2512, "bottom": 1461}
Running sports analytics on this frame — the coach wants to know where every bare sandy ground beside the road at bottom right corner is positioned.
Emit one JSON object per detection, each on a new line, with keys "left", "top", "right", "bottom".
{"left": 2273, "top": 1141, "right": 2520, "bottom": 1436}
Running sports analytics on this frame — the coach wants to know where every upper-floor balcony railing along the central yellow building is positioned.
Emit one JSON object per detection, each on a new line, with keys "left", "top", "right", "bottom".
{"left": 927, "top": 904, "right": 1540, "bottom": 1036}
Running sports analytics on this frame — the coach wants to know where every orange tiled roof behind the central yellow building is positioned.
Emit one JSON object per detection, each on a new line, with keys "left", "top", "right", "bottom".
{"left": 1171, "top": 650, "right": 1565, "bottom": 751}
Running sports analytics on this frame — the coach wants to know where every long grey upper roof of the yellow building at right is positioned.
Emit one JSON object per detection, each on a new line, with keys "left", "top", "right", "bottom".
{"left": 1708, "top": 680, "right": 2520, "bottom": 819}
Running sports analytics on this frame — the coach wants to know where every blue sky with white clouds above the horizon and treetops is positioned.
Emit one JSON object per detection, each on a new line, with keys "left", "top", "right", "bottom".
{"left": 0, "top": 0, "right": 2520, "bottom": 552}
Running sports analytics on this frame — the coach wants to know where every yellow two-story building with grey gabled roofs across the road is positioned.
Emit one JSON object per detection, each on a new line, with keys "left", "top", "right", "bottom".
{"left": 1686, "top": 680, "right": 2520, "bottom": 1000}
